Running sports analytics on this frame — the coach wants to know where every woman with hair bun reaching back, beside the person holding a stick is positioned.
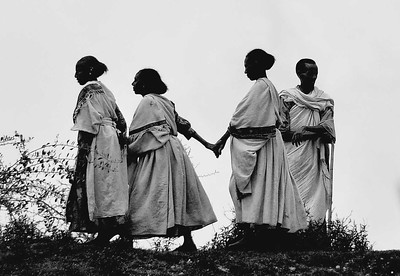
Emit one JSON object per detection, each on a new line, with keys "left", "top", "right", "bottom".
{"left": 215, "top": 49, "right": 306, "bottom": 249}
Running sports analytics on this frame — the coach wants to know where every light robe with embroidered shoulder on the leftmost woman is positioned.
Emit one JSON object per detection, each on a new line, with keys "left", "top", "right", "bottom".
{"left": 72, "top": 81, "right": 128, "bottom": 221}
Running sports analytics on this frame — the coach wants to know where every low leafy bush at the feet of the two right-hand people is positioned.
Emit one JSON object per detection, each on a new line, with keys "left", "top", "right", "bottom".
{"left": 204, "top": 211, "right": 372, "bottom": 252}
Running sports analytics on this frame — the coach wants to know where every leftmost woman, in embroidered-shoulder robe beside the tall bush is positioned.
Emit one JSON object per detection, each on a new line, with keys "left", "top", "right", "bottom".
{"left": 66, "top": 56, "right": 128, "bottom": 245}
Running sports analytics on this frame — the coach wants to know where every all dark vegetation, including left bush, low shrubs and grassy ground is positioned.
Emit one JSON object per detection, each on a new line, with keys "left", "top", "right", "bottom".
{"left": 0, "top": 133, "right": 400, "bottom": 275}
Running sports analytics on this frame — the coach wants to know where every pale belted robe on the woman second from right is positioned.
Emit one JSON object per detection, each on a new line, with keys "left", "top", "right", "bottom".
{"left": 229, "top": 78, "right": 307, "bottom": 232}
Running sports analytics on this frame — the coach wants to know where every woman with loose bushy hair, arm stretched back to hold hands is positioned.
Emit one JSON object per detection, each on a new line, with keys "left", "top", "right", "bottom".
{"left": 128, "top": 69, "right": 217, "bottom": 251}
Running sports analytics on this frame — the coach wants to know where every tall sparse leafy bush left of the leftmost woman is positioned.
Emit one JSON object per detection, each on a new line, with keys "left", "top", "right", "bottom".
{"left": 0, "top": 132, "right": 76, "bottom": 234}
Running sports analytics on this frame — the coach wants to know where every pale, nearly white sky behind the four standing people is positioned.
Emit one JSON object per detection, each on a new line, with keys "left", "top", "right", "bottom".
{"left": 0, "top": 0, "right": 400, "bottom": 250}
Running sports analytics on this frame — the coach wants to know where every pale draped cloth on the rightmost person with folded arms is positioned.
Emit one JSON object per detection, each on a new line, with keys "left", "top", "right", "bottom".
{"left": 279, "top": 87, "right": 336, "bottom": 220}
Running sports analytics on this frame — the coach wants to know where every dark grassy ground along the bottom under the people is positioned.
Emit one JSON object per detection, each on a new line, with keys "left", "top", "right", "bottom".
{"left": 0, "top": 240, "right": 400, "bottom": 276}
